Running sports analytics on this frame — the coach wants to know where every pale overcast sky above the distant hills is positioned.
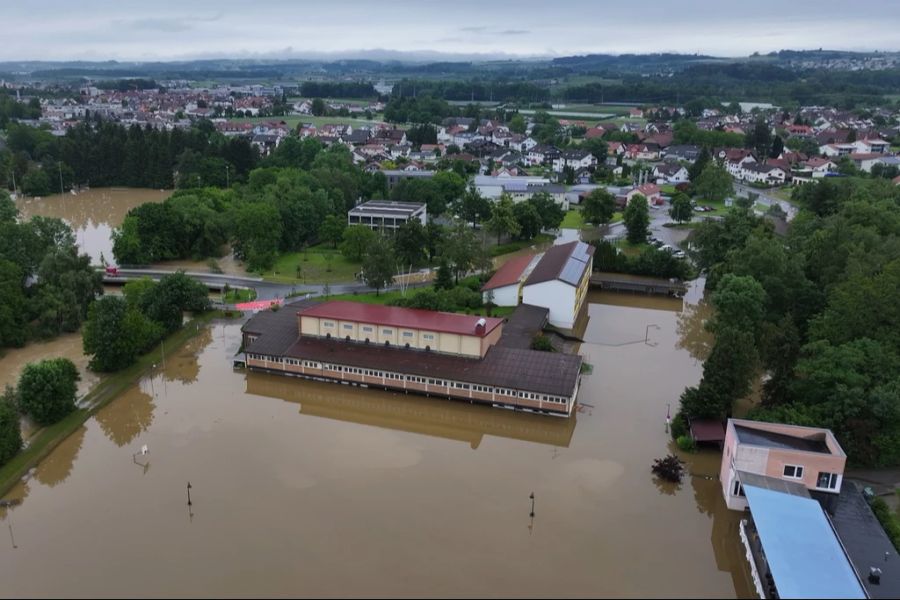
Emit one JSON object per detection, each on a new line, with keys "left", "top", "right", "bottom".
{"left": 7, "top": 0, "right": 900, "bottom": 60}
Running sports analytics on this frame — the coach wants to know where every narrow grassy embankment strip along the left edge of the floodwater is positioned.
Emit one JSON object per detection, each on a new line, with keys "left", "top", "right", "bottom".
{"left": 0, "top": 311, "right": 234, "bottom": 496}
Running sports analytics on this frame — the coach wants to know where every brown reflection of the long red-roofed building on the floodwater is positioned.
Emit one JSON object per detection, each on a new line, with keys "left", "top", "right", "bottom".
{"left": 247, "top": 373, "right": 576, "bottom": 450}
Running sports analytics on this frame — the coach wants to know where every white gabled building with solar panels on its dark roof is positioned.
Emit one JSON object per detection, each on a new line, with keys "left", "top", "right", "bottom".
{"left": 522, "top": 241, "right": 594, "bottom": 329}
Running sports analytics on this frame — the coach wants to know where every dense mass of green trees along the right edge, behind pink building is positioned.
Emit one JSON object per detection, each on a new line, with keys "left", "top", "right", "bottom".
{"left": 675, "top": 178, "right": 900, "bottom": 466}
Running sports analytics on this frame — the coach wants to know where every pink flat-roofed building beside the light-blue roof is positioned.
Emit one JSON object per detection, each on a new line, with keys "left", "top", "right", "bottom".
{"left": 719, "top": 419, "right": 847, "bottom": 510}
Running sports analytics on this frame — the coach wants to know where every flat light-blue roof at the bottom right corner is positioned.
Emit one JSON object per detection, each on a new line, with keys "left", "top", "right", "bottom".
{"left": 744, "top": 484, "right": 866, "bottom": 598}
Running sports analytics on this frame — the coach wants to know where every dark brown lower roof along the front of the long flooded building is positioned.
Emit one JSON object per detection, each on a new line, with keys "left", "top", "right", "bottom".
{"left": 282, "top": 336, "right": 581, "bottom": 396}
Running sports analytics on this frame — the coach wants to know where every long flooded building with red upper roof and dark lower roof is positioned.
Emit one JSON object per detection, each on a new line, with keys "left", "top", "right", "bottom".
{"left": 243, "top": 300, "right": 582, "bottom": 416}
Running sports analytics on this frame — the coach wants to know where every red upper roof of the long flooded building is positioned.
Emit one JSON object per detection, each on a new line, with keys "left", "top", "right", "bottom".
{"left": 297, "top": 300, "right": 503, "bottom": 337}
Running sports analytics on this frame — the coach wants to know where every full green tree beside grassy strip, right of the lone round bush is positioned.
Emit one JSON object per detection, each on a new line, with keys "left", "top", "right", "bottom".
{"left": 81, "top": 296, "right": 163, "bottom": 372}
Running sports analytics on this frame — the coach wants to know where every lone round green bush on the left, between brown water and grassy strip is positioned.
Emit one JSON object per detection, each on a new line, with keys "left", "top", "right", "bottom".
{"left": 17, "top": 358, "right": 81, "bottom": 425}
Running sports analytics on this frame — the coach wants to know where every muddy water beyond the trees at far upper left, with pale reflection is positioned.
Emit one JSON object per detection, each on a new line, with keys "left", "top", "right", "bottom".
{"left": 16, "top": 188, "right": 172, "bottom": 264}
